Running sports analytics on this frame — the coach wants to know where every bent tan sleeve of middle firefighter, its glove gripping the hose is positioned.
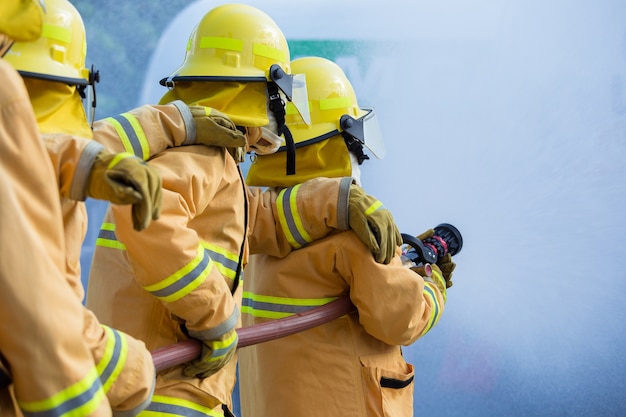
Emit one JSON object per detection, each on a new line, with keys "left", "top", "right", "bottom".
{"left": 111, "top": 146, "right": 236, "bottom": 339}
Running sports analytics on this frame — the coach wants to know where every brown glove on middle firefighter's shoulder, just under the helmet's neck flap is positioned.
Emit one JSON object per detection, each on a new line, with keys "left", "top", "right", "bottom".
{"left": 189, "top": 106, "right": 246, "bottom": 162}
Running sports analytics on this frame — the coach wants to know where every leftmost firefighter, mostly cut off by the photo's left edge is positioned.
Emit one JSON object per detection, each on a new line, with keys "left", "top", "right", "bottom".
{"left": 0, "top": 0, "right": 111, "bottom": 417}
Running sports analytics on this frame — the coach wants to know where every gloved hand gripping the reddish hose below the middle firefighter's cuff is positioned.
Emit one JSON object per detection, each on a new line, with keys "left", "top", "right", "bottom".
{"left": 183, "top": 329, "right": 238, "bottom": 378}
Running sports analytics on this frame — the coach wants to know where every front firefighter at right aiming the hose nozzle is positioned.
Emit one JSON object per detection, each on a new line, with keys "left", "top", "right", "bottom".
{"left": 239, "top": 57, "right": 451, "bottom": 417}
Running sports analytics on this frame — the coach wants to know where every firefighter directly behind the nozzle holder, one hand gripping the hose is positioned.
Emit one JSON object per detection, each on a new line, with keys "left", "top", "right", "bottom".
{"left": 87, "top": 4, "right": 399, "bottom": 416}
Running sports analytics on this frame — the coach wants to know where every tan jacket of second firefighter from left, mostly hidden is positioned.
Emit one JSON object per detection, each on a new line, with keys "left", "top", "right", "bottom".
{"left": 43, "top": 103, "right": 195, "bottom": 412}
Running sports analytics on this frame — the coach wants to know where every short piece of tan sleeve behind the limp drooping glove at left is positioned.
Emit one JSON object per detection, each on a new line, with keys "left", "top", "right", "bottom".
{"left": 43, "top": 134, "right": 104, "bottom": 201}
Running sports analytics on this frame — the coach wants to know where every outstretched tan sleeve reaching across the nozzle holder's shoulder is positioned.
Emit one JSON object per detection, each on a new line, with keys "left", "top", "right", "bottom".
{"left": 248, "top": 177, "right": 352, "bottom": 258}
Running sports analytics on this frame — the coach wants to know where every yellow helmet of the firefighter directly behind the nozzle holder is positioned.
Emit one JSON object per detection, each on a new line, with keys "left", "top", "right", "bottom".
{"left": 160, "top": 4, "right": 308, "bottom": 120}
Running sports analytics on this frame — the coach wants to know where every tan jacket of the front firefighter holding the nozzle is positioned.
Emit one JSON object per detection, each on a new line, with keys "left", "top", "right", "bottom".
{"left": 239, "top": 231, "right": 444, "bottom": 417}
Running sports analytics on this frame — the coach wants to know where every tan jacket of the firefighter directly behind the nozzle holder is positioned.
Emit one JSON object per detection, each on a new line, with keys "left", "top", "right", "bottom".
{"left": 87, "top": 140, "right": 350, "bottom": 416}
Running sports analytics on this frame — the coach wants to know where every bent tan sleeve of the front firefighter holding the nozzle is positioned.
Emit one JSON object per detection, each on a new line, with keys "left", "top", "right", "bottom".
{"left": 335, "top": 232, "right": 444, "bottom": 346}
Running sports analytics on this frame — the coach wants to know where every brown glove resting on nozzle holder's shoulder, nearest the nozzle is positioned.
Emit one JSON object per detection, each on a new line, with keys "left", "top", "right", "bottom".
{"left": 348, "top": 184, "right": 402, "bottom": 264}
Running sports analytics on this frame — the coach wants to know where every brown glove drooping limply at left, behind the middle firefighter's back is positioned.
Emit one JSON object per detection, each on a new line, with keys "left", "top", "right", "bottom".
{"left": 85, "top": 151, "right": 161, "bottom": 231}
